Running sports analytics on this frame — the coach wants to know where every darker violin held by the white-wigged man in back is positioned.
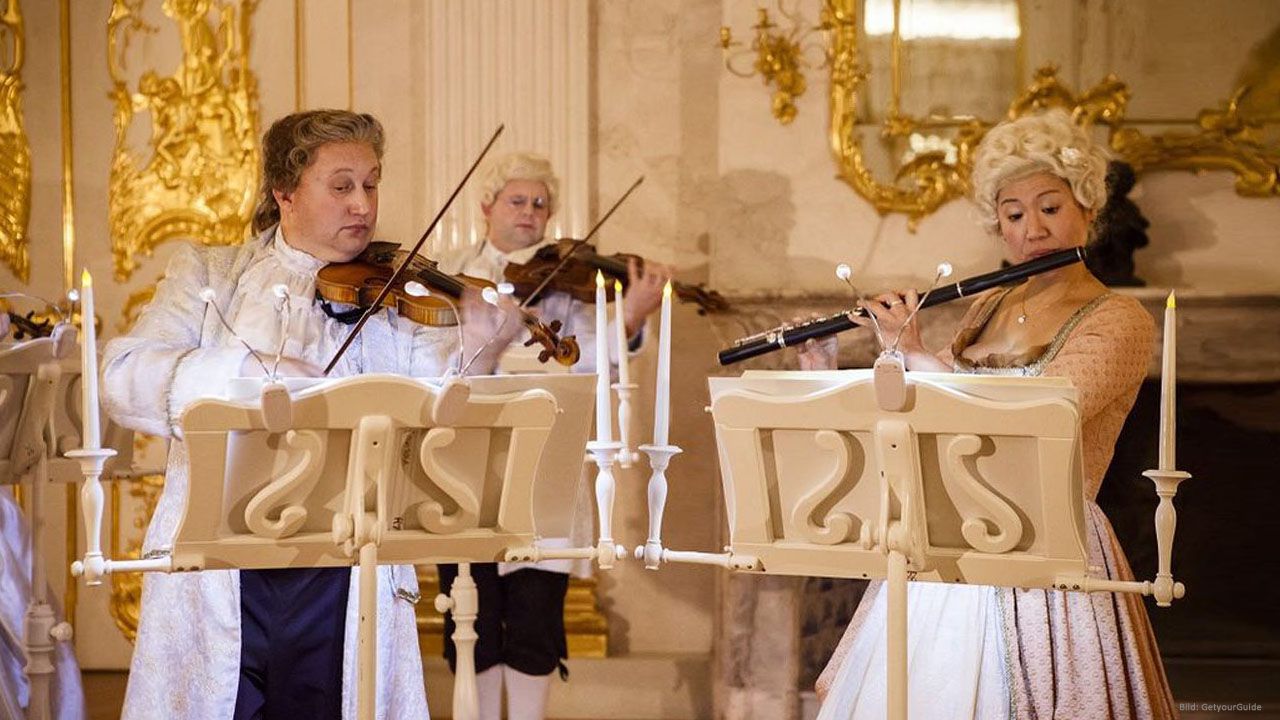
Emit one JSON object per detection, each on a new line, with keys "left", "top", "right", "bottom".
{"left": 503, "top": 240, "right": 728, "bottom": 315}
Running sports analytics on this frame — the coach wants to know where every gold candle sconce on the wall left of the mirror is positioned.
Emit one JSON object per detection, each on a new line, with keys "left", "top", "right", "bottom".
{"left": 719, "top": 0, "right": 831, "bottom": 124}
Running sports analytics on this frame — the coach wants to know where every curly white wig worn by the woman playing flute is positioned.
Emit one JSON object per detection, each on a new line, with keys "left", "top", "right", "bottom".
{"left": 973, "top": 109, "right": 1107, "bottom": 236}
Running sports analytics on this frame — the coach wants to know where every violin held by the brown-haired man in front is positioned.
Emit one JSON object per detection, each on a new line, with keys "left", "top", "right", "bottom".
{"left": 316, "top": 242, "right": 581, "bottom": 366}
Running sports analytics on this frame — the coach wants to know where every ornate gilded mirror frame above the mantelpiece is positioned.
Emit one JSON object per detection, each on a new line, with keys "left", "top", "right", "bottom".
{"left": 820, "top": 0, "right": 1280, "bottom": 229}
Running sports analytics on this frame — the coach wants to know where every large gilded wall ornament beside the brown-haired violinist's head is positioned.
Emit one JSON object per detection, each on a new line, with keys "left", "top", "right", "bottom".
{"left": 108, "top": 0, "right": 259, "bottom": 282}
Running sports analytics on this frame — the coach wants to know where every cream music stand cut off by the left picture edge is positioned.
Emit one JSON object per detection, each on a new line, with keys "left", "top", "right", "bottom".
{"left": 0, "top": 324, "right": 133, "bottom": 720}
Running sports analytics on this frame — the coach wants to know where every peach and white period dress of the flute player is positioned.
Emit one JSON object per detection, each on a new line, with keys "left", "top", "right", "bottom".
{"left": 818, "top": 290, "right": 1178, "bottom": 720}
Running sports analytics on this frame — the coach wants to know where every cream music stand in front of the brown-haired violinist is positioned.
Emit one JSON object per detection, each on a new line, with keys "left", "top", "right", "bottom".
{"left": 73, "top": 375, "right": 595, "bottom": 719}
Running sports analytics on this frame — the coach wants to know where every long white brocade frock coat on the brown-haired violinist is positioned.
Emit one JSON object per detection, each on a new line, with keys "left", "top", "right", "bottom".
{"left": 101, "top": 229, "right": 457, "bottom": 720}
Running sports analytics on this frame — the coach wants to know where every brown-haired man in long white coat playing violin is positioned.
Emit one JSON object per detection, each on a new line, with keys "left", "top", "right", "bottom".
{"left": 102, "top": 110, "right": 521, "bottom": 720}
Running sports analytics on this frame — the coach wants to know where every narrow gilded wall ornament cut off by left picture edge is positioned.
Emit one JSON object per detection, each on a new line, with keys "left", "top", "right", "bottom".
{"left": 0, "top": 0, "right": 31, "bottom": 282}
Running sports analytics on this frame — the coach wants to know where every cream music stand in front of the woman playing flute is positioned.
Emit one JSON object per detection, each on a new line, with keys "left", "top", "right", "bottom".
{"left": 652, "top": 366, "right": 1183, "bottom": 720}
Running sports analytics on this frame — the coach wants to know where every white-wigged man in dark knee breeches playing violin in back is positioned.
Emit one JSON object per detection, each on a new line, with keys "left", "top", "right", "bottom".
{"left": 436, "top": 152, "right": 671, "bottom": 720}
